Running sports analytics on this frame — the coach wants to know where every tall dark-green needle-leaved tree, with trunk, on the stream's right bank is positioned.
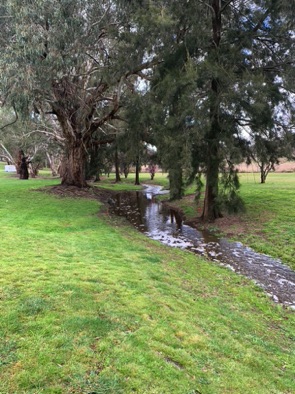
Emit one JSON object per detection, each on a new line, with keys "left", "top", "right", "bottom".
{"left": 149, "top": 0, "right": 295, "bottom": 220}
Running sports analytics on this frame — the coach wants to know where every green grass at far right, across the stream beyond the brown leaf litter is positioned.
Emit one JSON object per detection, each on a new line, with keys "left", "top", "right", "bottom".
{"left": 238, "top": 173, "right": 295, "bottom": 270}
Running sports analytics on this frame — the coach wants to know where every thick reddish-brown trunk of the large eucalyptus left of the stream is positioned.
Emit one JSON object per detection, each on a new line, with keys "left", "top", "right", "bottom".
{"left": 61, "top": 140, "right": 87, "bottom": 188}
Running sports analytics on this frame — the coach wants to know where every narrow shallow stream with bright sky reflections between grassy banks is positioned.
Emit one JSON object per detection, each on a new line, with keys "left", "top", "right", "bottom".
{"left": 112, "top": 186, "right": 295, "bottom": 310}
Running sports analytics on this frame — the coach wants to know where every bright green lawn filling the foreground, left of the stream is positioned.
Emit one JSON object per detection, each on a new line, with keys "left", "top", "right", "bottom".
{"left": 0, "top": 168, "right": 295, "bottom": 394}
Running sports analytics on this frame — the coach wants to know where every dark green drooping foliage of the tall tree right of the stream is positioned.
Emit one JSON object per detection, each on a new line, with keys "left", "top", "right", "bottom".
{"left": 147, "top": 1, "right": 295, "bottom": 218}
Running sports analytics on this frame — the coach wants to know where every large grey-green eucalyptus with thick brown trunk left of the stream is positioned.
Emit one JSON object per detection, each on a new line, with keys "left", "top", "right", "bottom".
{"left": 0, "top": 0, "right": 157, "bottom": 187}
